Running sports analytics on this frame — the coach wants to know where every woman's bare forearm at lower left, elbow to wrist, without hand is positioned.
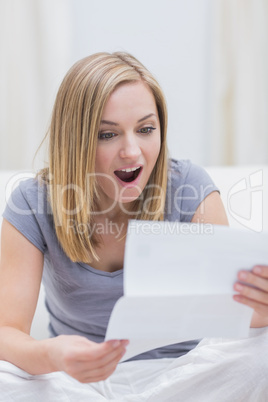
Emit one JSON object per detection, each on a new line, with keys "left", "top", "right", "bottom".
{"left": 0, "top": 327, "right": 55, "bottom": 375}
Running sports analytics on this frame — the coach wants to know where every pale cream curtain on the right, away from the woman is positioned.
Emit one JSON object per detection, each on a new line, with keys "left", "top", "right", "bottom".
{"left": 209, "top": 0, "right": 268, "bottom": 165}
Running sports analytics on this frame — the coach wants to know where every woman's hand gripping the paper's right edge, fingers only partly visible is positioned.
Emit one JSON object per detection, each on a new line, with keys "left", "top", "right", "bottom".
{"left": 233, "top": 265, "right": 268, "bottom": 328}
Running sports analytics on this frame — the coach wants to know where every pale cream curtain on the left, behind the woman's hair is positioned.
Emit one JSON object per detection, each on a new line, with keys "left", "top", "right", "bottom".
{"left": 0, "top": 0, "right": 72, "bottom": 169}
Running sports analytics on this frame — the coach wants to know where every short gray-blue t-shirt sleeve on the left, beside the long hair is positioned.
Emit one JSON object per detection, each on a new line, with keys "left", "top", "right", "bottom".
{"left": 2, "top": 179, "right": 46, "bottom": 253}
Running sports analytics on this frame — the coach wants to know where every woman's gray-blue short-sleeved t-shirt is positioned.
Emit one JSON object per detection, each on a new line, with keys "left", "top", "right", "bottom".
{"left": 3, "top": 160, "right": 218, "bottom": 359}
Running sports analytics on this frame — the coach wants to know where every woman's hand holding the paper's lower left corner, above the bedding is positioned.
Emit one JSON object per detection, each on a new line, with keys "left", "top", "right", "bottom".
{"left": 46, "top": 335, "right": 128, "bottom": 383}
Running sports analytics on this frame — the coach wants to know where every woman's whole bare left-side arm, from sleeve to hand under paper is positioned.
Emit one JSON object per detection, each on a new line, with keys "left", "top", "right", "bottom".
{"left": 0, "top": 219, "right": 126, "bottom": 382}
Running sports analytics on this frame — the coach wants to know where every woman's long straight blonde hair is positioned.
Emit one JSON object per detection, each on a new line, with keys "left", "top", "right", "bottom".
{"left": 42, "top": 52, "right": 167, "bottom": 263}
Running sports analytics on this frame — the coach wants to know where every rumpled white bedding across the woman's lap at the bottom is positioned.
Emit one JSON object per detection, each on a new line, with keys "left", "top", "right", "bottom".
{"left": 0, "top": 328, "right": 268, "bottom": 402}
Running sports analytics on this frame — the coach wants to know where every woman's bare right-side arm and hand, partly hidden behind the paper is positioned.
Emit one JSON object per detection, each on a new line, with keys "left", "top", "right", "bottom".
{"left": 192, "top": 192, "right": 268, "bottom": 328}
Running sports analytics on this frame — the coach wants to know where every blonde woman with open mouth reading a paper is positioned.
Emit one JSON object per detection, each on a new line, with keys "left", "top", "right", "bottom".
{"left": 0, "top": 53, "right": 268, "bottom": 398}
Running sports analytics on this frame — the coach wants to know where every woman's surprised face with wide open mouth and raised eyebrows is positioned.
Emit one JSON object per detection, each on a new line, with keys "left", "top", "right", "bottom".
{"left": 95, "top": 81, "right": 161, "bottom": 210}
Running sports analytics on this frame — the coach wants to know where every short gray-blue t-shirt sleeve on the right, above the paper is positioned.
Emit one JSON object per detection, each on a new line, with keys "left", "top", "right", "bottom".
{"left": 165, "top": 160, "right": 219, "bottom": 222}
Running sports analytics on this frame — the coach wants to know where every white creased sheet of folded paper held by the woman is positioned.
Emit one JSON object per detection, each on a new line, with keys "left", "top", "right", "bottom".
{"left": 106, "top": 221, "right": 268, "bottom": 361}
